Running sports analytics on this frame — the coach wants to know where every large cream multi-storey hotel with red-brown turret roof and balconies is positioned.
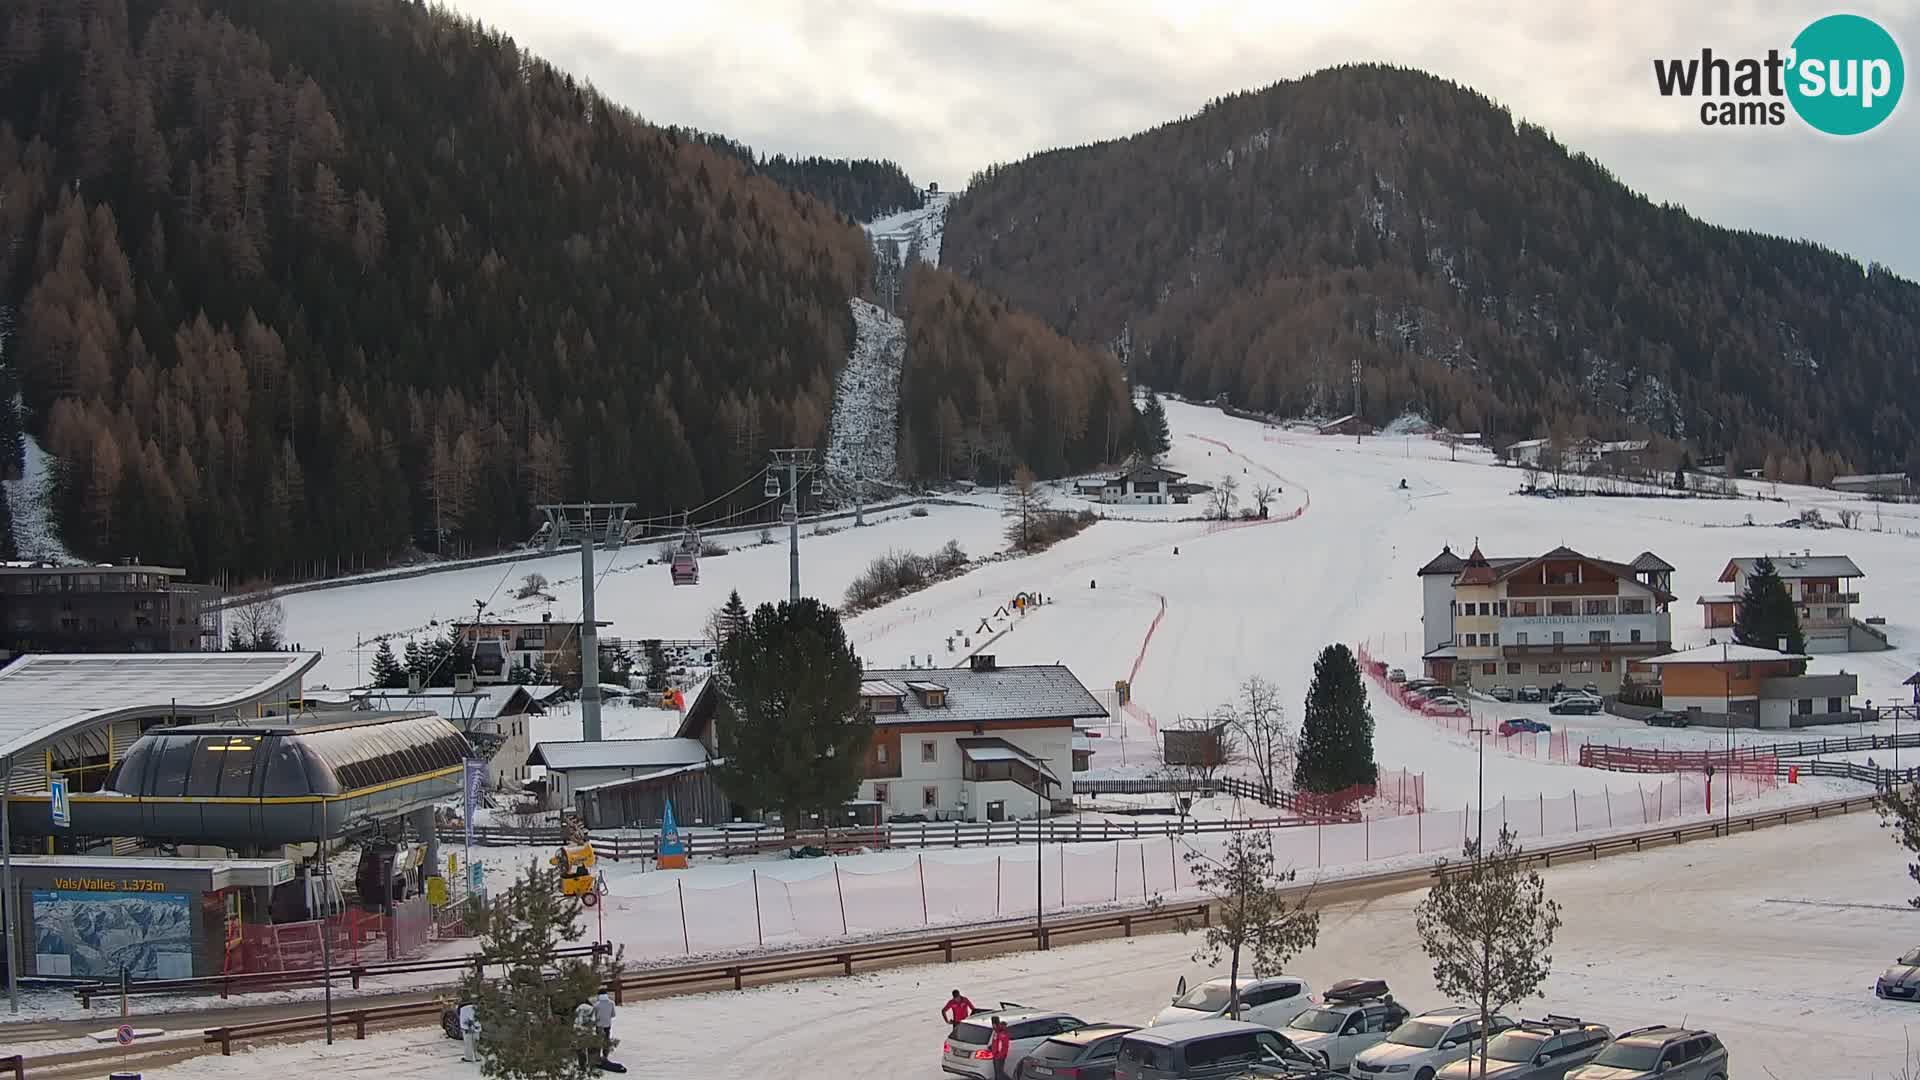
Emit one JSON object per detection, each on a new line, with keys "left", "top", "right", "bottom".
{"left": 1419, "top": 544, "right": 1674, "bottom": 692}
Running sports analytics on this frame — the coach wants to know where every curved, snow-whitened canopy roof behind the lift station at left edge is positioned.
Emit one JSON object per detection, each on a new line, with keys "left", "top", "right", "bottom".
{"left": 0, "top": 653, "right": 321, "bottom": 757}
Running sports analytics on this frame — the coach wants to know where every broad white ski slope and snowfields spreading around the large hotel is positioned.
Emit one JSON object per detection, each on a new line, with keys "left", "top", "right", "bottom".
{"left": 286, "top": 402, "right": 1920, "bottom": 807}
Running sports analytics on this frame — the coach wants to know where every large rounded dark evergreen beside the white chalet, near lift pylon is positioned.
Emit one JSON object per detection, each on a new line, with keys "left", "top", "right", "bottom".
{"left": 714, "top": 596, "right": 874, "bottom": 832}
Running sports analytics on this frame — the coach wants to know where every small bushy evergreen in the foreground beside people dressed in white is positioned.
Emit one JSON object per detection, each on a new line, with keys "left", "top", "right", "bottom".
{"left": 461, "top": 863, "right": 620, "bottom": 1080}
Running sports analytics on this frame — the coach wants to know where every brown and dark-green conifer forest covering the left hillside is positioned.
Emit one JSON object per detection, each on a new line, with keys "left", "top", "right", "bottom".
{"left": 0, "top": 0, "right": 870, "bottom": 577}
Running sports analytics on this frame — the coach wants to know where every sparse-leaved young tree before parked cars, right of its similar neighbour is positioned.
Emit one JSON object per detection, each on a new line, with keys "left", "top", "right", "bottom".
{"left": 1415, "top": 826, "right": 1559, "bottom": 1076}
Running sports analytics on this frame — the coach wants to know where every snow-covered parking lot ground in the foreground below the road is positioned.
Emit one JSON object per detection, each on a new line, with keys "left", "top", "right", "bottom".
{"left": 127, "top": 817, "right": 1920, "bottom": 1080}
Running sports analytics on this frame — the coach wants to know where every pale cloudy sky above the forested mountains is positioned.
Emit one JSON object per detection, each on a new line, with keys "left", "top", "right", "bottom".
{"left": 451, "top": 0, "right": 1920, "bottom": 279}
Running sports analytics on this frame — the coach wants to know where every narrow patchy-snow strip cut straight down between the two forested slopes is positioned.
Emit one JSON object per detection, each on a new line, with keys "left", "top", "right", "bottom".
{"left": 828, "top": 296, "right": 906, "bottom": 482}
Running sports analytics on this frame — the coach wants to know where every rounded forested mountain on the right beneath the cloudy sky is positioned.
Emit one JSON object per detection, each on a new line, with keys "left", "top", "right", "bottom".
{"left": 941, "top": 65, "right": 1920, "bottom": 471}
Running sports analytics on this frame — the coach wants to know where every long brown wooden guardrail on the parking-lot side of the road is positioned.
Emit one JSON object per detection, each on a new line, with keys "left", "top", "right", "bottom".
{"left": 18, "top": 796, "right": 1874, "bottom": 1078}
